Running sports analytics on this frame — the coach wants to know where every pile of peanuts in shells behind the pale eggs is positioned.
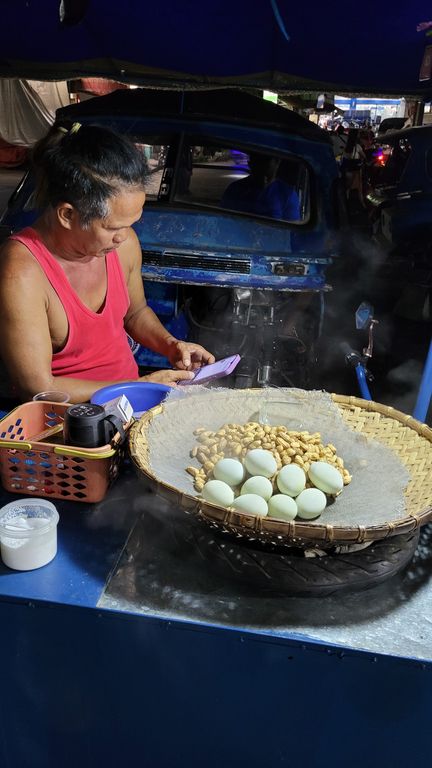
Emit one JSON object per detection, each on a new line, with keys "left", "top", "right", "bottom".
{"left": 186, "top": 421, "right": 352, "bottom": 493}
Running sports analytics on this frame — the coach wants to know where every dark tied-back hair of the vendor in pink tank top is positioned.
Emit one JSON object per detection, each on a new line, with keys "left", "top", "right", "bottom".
{"left": 32, "top": 123, "right": 147, "bottom": 228}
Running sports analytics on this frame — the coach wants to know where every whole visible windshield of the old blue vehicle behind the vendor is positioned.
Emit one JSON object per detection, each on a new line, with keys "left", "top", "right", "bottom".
{"left": 128, "top": 135, "right": 310, "bottom": 224}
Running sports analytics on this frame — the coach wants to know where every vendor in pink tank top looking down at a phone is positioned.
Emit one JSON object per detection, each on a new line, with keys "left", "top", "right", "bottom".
{"left": 0, "top": 123, "right": 214, "bottom": 403}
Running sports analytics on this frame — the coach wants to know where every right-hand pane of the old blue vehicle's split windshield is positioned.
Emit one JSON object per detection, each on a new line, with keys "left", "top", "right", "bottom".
{"left": 170, "top": 142, "right": 309, "bottom": 223}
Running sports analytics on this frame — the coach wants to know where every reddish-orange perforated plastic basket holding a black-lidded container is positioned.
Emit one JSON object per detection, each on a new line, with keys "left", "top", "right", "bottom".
{"left": 0, "top": 400, "right": 124, "bottom": 502}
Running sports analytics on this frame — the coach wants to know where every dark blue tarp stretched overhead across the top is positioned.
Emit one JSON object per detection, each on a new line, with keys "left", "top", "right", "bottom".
{"left": 0, "top": 0, "right": 432, "bottom": 96}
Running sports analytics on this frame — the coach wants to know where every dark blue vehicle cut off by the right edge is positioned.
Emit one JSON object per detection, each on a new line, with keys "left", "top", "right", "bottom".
{"left": 367, "top": 125, "right": 432, "bottom": 321}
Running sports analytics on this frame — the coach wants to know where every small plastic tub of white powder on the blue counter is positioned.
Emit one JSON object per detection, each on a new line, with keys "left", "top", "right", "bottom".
{"left": 0, "top": 499, "right": 59, "bottom": 571}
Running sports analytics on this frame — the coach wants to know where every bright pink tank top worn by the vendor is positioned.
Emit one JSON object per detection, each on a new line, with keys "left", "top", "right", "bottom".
{"left": 11, "top": 227, "right": 138, "bottom": 381}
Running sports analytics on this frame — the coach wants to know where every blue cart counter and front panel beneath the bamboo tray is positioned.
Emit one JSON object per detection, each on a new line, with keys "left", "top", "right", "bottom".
{"left": 0, "top": 467, "right": 432, "bottom": 768}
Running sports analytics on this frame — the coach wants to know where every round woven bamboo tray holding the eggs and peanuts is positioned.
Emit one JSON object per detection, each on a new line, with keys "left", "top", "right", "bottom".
{"left": 129, "top": 395, "right": 432, "bottom": 549}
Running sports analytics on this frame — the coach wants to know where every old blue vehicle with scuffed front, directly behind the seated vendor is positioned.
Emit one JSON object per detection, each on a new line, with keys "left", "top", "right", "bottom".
{"left": 2, "top": 89, "right": 344, "bottom": 386}
